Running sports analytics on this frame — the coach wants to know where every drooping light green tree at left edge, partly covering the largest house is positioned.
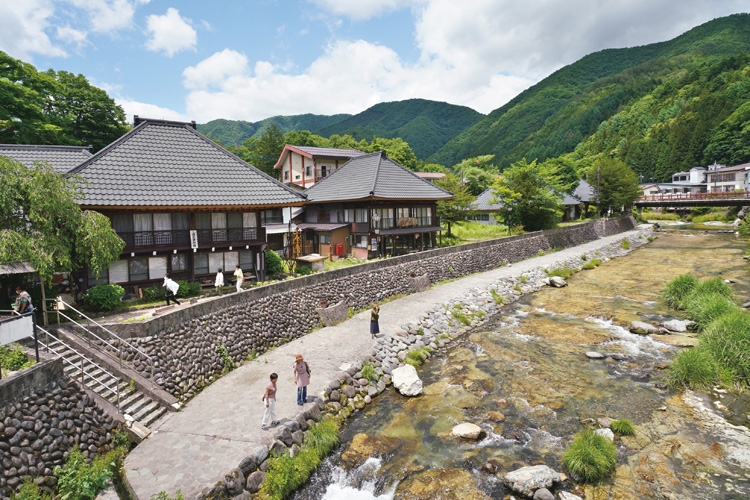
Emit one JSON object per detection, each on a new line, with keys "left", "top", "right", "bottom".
{"left": 0, "top": 156, "right": 125, "bottom": 281}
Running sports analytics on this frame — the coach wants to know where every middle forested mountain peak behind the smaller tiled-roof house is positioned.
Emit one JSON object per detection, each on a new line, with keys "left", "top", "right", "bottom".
{"left": 311, "top": 99, "right": 484, "bottom": 159}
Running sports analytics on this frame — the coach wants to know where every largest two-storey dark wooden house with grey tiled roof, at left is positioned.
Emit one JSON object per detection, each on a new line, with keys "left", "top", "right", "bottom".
{"left": 70, "top": 117, "right": 304, "bottom": 292}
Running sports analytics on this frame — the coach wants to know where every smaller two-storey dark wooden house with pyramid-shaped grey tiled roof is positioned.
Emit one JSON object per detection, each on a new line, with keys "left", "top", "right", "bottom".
{"left": 298, "top": 151, "right": 453, "bottom": 258}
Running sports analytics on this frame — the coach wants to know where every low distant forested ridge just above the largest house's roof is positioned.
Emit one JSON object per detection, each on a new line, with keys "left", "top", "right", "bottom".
{"left": 198, "top": 113, "right": 352, "bottom": 147}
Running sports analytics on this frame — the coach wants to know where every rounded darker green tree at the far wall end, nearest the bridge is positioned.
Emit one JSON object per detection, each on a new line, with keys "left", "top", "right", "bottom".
{"left": 587, "top": 158, "right": 642, "bottom": 215}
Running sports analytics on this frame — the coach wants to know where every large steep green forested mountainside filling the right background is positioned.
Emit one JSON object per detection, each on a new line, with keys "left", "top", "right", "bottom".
{"left": 428, "top": 14, "right": 750, "bottom": 180}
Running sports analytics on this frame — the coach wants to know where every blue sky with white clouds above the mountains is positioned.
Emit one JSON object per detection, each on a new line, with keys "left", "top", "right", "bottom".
{"left": 0, "top": 0, "right": 750, "bottom": 123}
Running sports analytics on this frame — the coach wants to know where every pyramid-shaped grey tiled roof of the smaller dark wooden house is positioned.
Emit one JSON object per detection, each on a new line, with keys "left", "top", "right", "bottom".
{"left": 305, "top": 151, "right": 453, "bottom": 203}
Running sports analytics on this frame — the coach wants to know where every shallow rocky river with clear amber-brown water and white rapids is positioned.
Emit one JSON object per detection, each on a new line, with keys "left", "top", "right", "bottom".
{"left": 294, "top": 231, "right": 750, "bottom": 500}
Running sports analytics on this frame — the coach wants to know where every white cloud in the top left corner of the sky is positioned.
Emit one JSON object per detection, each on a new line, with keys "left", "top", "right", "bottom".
{"left": 0, "top": 0, "right": 67, "bottom": 61}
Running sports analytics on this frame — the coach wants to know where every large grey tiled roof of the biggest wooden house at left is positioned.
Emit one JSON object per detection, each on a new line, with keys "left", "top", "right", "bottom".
{"left": 70, "top": 117, "right": 304, "bottom": 208}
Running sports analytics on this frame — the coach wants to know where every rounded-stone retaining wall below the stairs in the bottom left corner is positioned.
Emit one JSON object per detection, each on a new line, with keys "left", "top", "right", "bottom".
{"left": 0, "top": 358, "right": 119, "bottom": 498}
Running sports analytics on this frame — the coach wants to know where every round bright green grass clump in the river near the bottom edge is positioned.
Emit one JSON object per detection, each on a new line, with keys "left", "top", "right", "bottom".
{"left": 563, "top": 430, "right": 617, "bottom": 483}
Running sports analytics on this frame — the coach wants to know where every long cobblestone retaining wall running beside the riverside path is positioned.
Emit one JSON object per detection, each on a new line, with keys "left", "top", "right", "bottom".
{"left": 106, "top": 217, "right": 635, "bottom": 400}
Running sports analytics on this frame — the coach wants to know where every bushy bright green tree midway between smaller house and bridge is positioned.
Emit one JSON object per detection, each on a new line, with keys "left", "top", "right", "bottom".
{"left": 492, "top": 159, "right": 561, "bottom": 231}
